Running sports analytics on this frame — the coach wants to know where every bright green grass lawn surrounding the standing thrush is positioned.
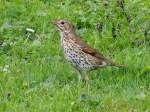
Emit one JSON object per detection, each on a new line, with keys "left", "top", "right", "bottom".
{"left": 0, "top": 0, "right": 150, "bottom": 112}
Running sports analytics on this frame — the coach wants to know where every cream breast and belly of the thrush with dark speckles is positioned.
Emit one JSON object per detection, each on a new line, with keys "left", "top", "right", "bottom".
{"left": 62, "top": 39, "right": 97, "bottom": 70}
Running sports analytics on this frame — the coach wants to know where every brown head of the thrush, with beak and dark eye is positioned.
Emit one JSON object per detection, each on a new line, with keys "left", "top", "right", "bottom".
{"left": 51, "top": 19, "right": 74, "bottom": 32}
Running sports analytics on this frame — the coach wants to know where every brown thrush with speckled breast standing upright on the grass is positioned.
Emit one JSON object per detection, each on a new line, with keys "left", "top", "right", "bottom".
{"left": 50, "top": 19, "right": 125, "bottom": 81}
